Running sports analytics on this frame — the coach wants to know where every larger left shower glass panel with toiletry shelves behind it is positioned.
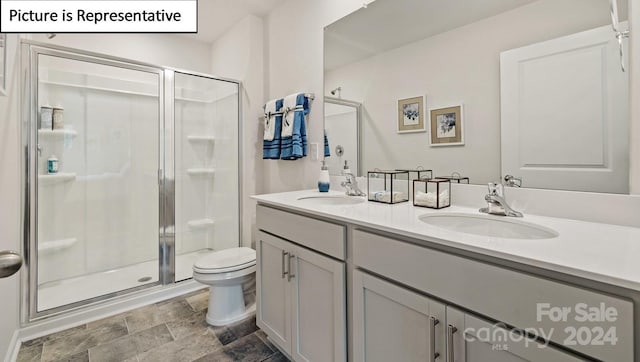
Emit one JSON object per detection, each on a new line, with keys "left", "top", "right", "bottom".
{"left": 29, "top": 48, "right": 163, "bottom": 315}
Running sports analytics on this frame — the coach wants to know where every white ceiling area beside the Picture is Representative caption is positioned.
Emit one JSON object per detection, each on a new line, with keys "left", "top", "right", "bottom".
{"left": 181, "top": 0, "right": 284, "bottom": 43}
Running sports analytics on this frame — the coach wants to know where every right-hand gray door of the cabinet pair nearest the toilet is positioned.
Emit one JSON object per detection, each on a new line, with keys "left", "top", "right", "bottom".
{"left": 290, "top": 247, "right": 347, "bottom": 361}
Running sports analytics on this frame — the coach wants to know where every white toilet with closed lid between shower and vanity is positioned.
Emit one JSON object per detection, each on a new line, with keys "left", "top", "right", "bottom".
{"left": 193, "top": 247, "right": 256, "bottom": 326}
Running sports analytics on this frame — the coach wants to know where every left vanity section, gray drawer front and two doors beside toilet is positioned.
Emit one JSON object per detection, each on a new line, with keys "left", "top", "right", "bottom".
{"left": 256, "top": 206, "right": 347, "bottom": 361}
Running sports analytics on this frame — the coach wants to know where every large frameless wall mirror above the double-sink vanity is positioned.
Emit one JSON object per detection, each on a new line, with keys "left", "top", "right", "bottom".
{"left": 324, "top": 0, "right": 629, "bottom": 194}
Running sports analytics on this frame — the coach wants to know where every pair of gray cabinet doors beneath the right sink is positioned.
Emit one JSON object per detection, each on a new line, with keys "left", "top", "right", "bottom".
{"left": 352, "top": 270, "right": 584, "bottom": 362}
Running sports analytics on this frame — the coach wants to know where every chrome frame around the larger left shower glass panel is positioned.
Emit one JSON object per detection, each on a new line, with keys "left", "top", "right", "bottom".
{"left": 20, "top": 40, "right": 168, "bottom": 323}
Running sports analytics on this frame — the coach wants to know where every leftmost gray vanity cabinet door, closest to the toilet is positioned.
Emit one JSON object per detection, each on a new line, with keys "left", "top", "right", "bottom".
{"left": 256, "top": 232, "right": 291, "bottom": 354}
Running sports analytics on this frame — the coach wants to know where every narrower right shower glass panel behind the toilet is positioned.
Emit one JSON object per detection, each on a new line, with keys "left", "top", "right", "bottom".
{"left": 173, "top": 72, "right": 240, "bottom": 281}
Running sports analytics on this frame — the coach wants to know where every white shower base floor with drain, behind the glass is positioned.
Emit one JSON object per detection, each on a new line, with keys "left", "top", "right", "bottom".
{"left": 38, "top": 249, "right": 210, "bottom": 311}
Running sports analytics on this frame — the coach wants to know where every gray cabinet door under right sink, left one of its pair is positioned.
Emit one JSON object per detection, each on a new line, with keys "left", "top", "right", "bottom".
{"left": 353, "top": 270, "right": 445, "bottom": 362}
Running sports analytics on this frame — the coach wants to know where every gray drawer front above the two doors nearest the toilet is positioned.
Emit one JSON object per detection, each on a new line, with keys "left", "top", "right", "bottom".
{"left": 256, "top": 205, "right": 346, "bottom": 260}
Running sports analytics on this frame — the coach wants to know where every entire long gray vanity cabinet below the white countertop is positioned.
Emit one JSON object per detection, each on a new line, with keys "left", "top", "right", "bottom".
{"left": 256, "top": 205, "right": 637, "bottom": 362}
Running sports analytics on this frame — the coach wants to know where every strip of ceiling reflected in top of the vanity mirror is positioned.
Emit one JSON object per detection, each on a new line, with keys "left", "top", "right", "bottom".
{"left": 325, "top": 0, "right": 534, "bottom": 70}
